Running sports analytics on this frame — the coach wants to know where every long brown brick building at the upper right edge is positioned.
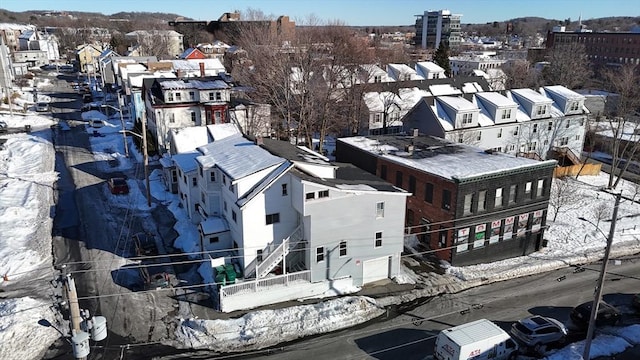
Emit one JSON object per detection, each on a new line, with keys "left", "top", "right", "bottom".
{"left": 547, "top": 31, "right": 640, "bottom": 65}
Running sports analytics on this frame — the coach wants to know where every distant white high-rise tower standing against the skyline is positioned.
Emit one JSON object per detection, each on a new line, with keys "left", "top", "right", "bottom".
{"left": 414, "top": 10, "right": 462, "bottom": 49}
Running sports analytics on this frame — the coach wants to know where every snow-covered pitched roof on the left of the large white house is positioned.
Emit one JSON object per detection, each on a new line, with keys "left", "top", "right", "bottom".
{"left": 197, "top": 134, "right": 285, "bottom": 180}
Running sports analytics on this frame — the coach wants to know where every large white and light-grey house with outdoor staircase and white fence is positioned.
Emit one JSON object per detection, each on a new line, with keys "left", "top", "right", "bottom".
{"left": 172, "top": 135, "right": 408, "bottom": 312}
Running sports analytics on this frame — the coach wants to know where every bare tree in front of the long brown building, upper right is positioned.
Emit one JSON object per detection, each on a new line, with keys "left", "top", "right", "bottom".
{"left": 542, "top": 43, "right": 592, "bottom": 89}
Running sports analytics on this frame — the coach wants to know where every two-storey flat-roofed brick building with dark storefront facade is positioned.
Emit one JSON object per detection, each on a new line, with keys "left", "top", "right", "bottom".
{"left": 336, "top": 131, "right": 556, "bottom": 266}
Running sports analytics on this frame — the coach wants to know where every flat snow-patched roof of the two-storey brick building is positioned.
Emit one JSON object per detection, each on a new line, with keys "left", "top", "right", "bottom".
{"left": 338, "top": 135, "right": 556, "bottom": 180}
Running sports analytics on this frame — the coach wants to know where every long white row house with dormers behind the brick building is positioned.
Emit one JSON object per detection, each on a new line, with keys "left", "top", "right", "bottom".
{"left": 402, "top": 85, "right": 588, "bottom": 164}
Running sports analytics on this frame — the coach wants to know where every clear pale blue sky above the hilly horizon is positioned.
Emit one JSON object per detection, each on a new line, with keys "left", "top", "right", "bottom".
{"left": 0, "top": 0, "right": 640, "bottom": 26}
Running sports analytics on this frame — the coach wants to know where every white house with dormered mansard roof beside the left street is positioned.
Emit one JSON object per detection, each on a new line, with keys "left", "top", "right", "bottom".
{"left": 142, "top": 76, "right": 231, "bottom": 153}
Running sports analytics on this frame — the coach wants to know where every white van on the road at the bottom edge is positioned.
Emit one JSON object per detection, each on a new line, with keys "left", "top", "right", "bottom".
{"left": 434, "top": 319, "right": 518, "bottom": 360}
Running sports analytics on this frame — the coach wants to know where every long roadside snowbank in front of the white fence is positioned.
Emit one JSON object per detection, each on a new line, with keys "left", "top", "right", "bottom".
{"left": 172, "top": 296, "right": 385, "bottom": 352}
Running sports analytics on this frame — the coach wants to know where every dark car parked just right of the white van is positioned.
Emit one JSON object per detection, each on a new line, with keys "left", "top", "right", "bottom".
{"left": 511, "top": 315, "right": 567, "bottom": 352}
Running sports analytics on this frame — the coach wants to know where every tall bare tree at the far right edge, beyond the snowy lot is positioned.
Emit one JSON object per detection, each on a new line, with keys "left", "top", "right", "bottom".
{"left": 603, "top": 64, "right": 640, "bottom": 189}
